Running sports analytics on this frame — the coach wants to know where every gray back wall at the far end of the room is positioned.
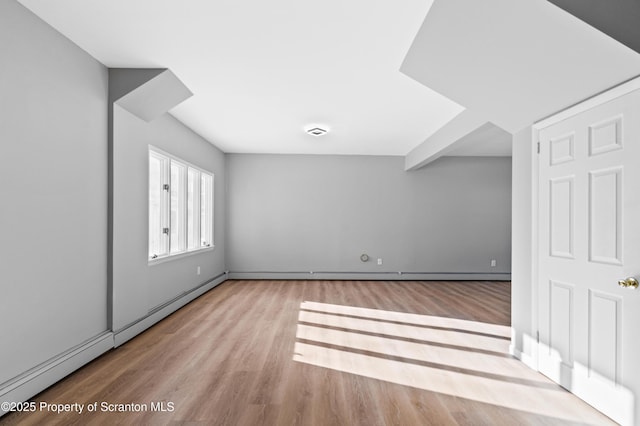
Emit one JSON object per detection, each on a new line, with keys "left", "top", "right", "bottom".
{"left": 227, "top": 154, "right": 511, "bottom": 273}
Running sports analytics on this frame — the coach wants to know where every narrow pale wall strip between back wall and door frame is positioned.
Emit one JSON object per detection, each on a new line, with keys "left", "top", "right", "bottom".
{"left": 511, "top": 127, "right": 535, "bottom": 362}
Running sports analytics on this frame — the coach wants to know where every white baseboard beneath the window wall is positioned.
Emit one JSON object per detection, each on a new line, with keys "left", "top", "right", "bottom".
{"left": 113, "top": 272, "right": 228, "bottom": 348}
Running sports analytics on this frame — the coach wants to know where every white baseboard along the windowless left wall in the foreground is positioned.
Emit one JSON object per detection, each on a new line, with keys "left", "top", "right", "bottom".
{"left": 0, "top": 332, "right": 113, "bottom": 416}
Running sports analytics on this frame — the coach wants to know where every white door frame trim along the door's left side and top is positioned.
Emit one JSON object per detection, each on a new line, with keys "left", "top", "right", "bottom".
{"left": 521, "top": 76, "right": 640, "bottom": 371}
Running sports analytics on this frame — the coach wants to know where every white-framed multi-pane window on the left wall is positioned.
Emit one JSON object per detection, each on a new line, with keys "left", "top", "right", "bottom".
{"left": 149, "top": 147, "right": 213, "bottom": 260}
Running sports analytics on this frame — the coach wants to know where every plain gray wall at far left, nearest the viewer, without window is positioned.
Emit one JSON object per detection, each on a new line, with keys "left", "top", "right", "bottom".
{"left": 0, "top": 0, "right": 107, "bottom": 383}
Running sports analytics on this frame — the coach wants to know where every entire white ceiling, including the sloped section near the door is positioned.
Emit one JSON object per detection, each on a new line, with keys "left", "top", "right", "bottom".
{"left": 19, "top": 0, "right": 640, "bottom": 156}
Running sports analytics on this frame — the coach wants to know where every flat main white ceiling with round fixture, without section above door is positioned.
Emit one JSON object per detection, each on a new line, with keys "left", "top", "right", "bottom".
{"left": 20, "top": 0, "right": 463, "bottom": 155}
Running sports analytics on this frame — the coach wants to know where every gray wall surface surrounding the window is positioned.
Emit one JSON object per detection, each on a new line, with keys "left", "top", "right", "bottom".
{"left": 113, "top": 105, "right": 225, "bottom": 331}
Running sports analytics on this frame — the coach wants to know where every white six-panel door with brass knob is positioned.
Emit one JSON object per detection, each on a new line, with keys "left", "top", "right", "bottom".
{"left": 538, "top": 85, "right": 640, "bottom": 425}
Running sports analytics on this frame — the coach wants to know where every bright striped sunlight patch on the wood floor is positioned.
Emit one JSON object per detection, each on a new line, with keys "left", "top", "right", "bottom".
{"left": 293, "top": 302, "right": 602, "bottom": 423}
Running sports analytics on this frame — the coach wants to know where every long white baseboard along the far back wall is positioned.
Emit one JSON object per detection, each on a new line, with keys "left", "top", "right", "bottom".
{"left": 229, "top": 271, "right": 511, "bottom": 281}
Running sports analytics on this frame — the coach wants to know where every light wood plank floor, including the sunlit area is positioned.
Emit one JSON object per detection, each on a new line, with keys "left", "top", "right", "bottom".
{"left": 0, "top": 281, "right": 611, "bottom": 426}
